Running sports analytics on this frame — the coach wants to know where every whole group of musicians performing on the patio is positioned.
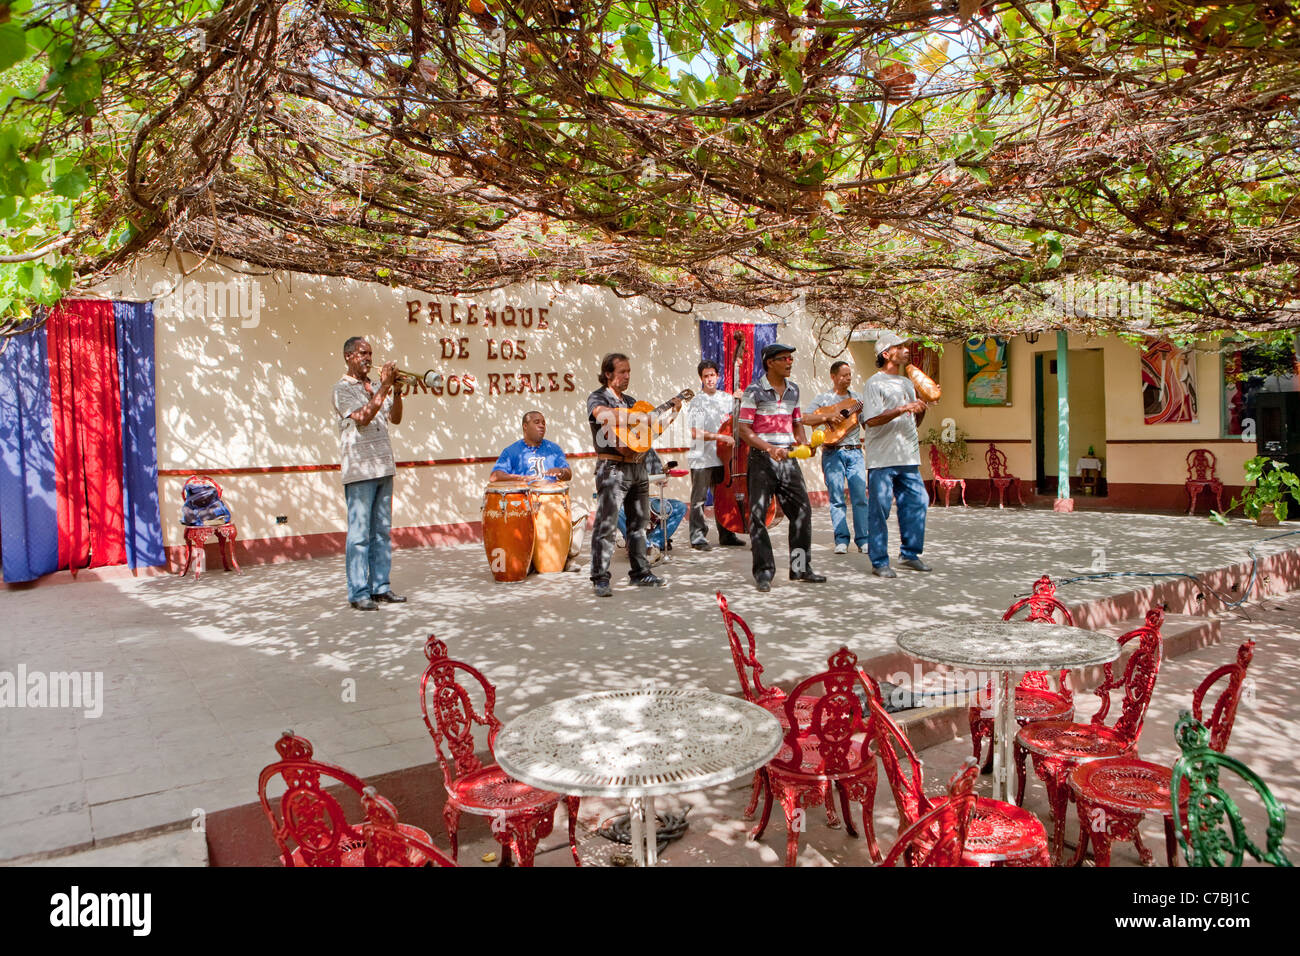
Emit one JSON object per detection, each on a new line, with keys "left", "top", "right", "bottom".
{"left": 325, "top": 333, "right": 937, "bottom": 610}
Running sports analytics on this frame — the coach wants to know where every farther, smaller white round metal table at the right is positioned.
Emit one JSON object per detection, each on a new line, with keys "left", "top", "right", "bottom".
{"left": 897, "top": 620, "right": 1119, "bottom": 800}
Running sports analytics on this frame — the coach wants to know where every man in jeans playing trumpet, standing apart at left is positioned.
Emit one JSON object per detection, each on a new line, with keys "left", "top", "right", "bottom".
{"left": 334, "top": 336, "right": 406, "bottom": 611}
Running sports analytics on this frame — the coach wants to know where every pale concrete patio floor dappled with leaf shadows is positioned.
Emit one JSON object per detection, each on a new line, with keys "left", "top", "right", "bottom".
{"left": 0, "top": 507, "right": 1300, "bottom": 862}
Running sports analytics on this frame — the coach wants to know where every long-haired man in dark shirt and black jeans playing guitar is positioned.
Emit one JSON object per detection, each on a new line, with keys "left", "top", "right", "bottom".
{"left": 586, "top": 352, "right": 683, "bottom": 597}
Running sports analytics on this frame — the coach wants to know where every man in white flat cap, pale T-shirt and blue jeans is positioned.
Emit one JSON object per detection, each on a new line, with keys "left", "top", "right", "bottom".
{"left": 862, "top": 332, "right": 931, "bottom": 578}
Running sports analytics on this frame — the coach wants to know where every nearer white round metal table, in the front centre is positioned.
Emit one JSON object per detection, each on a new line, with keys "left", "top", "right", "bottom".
{"left": 494, "top": 688, "right": 783, "bottom": 866}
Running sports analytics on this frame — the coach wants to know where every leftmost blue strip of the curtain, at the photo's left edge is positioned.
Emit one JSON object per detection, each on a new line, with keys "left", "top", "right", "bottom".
{"left": 0, "top": 323, "right": 59, "bottom": 581}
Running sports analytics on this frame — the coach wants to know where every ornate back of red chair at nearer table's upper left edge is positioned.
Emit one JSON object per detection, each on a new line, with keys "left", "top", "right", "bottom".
{"left": 420, "top": 635, "right": 502, "bottom": 788}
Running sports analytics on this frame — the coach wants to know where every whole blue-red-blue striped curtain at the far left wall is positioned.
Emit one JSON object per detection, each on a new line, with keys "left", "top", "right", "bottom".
{"left": 0, "top": 300, "right": 165, "bottom": 581}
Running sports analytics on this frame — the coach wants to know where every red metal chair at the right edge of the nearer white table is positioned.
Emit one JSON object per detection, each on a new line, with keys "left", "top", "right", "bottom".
{"left": 753, "top": 648, "right": 880, "bottom": 866}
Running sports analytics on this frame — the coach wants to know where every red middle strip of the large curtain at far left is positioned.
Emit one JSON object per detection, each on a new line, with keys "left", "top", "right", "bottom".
{"left": 46, "top": 300, "right": 126, "bottom": 571}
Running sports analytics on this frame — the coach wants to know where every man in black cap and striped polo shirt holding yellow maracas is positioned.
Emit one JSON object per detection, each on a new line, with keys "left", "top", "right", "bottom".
{"left": 740, "top": 343, "right": 826, "bottom": 591}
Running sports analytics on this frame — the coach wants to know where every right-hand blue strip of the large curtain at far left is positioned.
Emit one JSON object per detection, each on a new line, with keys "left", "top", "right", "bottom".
{"left": 113, "top": 302, "right": 166, "bottom": 568}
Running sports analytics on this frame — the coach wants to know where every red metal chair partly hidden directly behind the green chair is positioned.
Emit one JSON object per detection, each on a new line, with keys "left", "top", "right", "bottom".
{"left": 1070, "top": 641, "right": 1255, "bottom": 866}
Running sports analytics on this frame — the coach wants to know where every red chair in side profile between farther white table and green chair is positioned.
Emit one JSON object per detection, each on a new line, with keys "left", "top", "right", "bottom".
{"left": 1015, "top": 607, "right": 1165, "bottom": 861}
